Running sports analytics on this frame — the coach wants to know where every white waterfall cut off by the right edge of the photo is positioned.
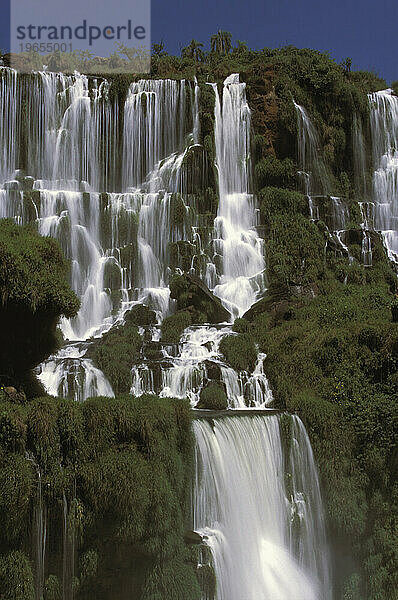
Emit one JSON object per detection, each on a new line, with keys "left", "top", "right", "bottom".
{"left": 369, "top": 89, "right": 398, "bottom": 263}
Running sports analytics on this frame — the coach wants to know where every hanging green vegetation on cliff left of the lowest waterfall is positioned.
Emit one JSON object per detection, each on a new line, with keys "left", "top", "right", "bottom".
{"left": 0, "top": 396, "right": 199, "bottom": 600}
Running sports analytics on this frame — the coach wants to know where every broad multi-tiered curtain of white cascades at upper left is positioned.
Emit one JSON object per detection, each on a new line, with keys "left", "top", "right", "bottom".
{"left": 0, "top": 68, "right": 199, "bottom": 398}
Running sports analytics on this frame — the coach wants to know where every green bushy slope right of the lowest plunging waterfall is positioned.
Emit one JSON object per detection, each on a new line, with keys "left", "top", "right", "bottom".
{"left": 243, "top": 284, "right": 398, "bottom": 599}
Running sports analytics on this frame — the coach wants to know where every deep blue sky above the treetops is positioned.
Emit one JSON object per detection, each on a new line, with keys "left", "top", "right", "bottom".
{"left": 0, "top": 0, "right": 398, "bottom": 81}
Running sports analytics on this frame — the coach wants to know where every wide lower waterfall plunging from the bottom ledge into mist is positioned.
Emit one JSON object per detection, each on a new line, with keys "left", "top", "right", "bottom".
{"left": 193, "top": 415, "right": 332, "bottom": 600}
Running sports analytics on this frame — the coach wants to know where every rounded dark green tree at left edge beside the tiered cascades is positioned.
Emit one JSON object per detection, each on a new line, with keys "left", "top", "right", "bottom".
{"left": 0, "top": 219, "right": 79, "bottom": 392}
